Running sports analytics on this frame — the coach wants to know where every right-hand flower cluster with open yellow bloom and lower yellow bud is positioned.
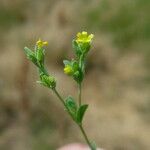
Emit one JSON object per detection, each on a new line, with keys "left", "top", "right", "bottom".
{"left": 64, "top": 31, "right": 94, "bottom": 83}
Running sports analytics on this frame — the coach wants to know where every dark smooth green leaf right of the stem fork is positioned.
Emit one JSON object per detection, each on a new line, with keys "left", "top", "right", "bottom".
{"left": 77, "top": 104, "right": 88, "bottom": 123}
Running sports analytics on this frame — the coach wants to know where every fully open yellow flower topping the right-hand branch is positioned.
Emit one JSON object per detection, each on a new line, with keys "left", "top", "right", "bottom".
{"left": 76, "top": 31, "right": 94, "bottom": 43}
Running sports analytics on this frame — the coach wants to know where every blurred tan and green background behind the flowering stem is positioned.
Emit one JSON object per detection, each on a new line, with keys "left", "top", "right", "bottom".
{"left": 0, "top": 0, "right": 150, "bottom": 150}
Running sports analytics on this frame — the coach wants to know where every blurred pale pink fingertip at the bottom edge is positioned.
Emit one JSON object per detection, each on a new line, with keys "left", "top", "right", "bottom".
{"left": 58, "top": 143, "right": 104, "bottom": 150}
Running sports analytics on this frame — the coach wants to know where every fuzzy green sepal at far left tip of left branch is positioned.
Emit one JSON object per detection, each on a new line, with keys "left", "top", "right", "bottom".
{"left": 24, "top": 47, "right": 38, "bottom": 66}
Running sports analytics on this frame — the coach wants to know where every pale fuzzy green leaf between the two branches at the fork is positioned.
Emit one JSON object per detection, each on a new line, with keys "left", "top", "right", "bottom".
{"left": 65, "top": 96, "right": 77, "bottom": 121}
